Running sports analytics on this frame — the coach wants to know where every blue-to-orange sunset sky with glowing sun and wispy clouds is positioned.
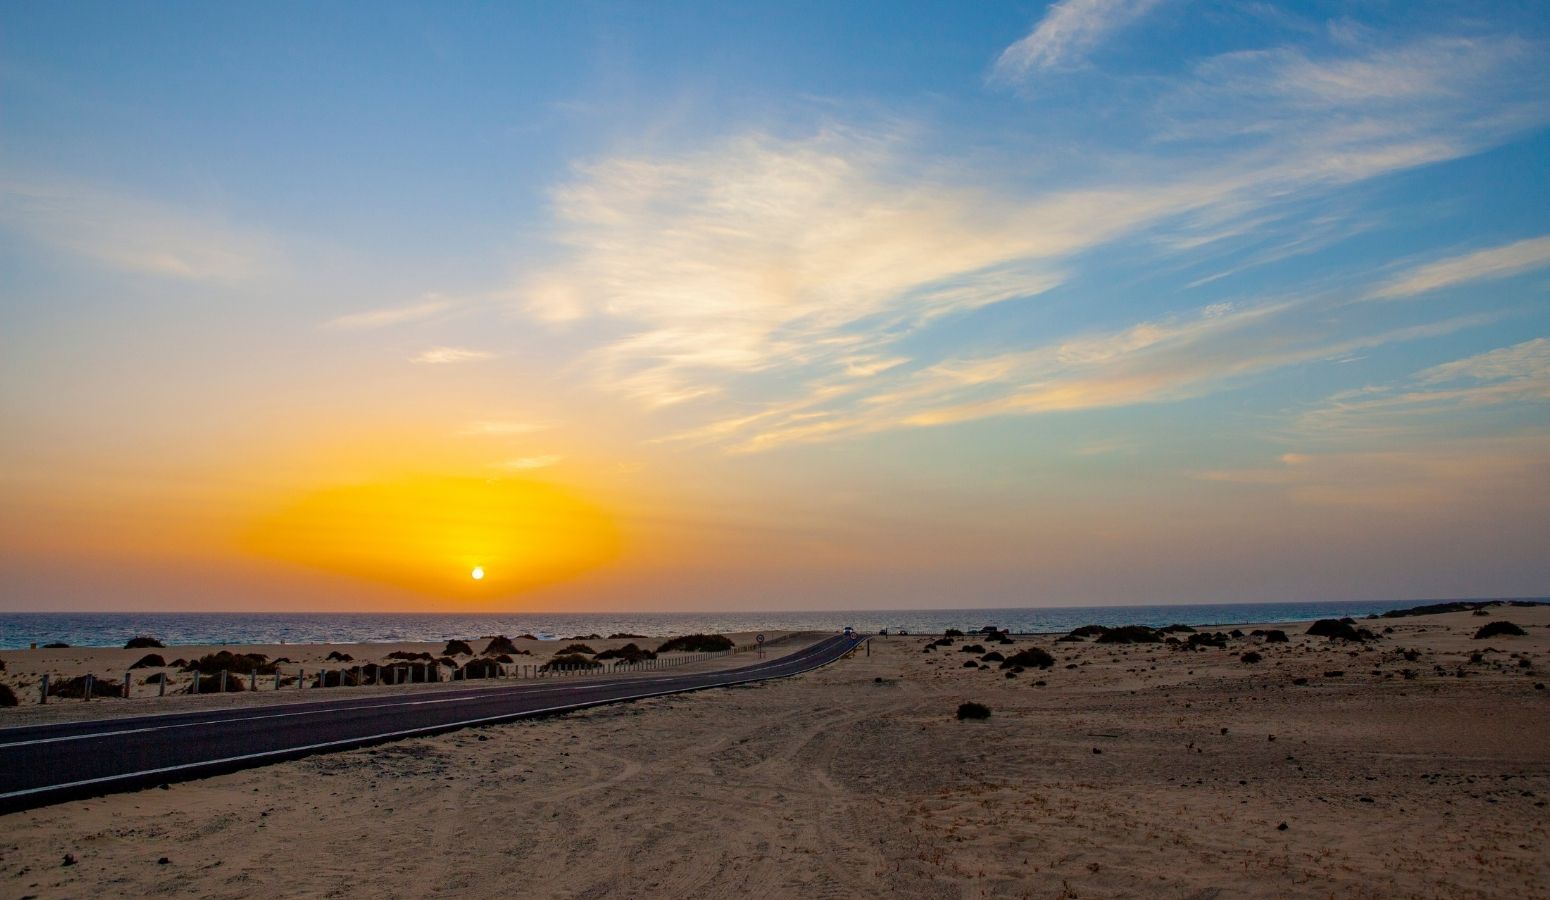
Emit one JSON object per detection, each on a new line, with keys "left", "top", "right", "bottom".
{"left": 0, "top": 0, "right": 1550, "bottom": 612}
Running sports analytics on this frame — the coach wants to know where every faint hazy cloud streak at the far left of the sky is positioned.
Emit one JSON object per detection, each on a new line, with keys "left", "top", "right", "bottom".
{"left": 0, "top": 178, "right": 268, "bottom": 280}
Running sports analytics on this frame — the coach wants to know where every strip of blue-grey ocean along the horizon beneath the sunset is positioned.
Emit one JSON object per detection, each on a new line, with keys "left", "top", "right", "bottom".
{"left": 0, "top": 599, "right": 1537, "bottom": 649}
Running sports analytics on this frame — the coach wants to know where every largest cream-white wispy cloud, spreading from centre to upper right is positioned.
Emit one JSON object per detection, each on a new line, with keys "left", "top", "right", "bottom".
{"left": 524, "top": 24, "right": 1545, "bottom": 451}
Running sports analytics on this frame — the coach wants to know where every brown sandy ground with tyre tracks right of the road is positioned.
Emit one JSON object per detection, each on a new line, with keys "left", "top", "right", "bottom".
{"left": 0, "top": 609, "right": 1550, "bottom": 898}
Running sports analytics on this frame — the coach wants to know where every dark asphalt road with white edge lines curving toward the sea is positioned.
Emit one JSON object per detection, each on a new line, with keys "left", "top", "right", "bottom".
{"left": 0, "top": 637, "right": 863, "bottom": 813}
